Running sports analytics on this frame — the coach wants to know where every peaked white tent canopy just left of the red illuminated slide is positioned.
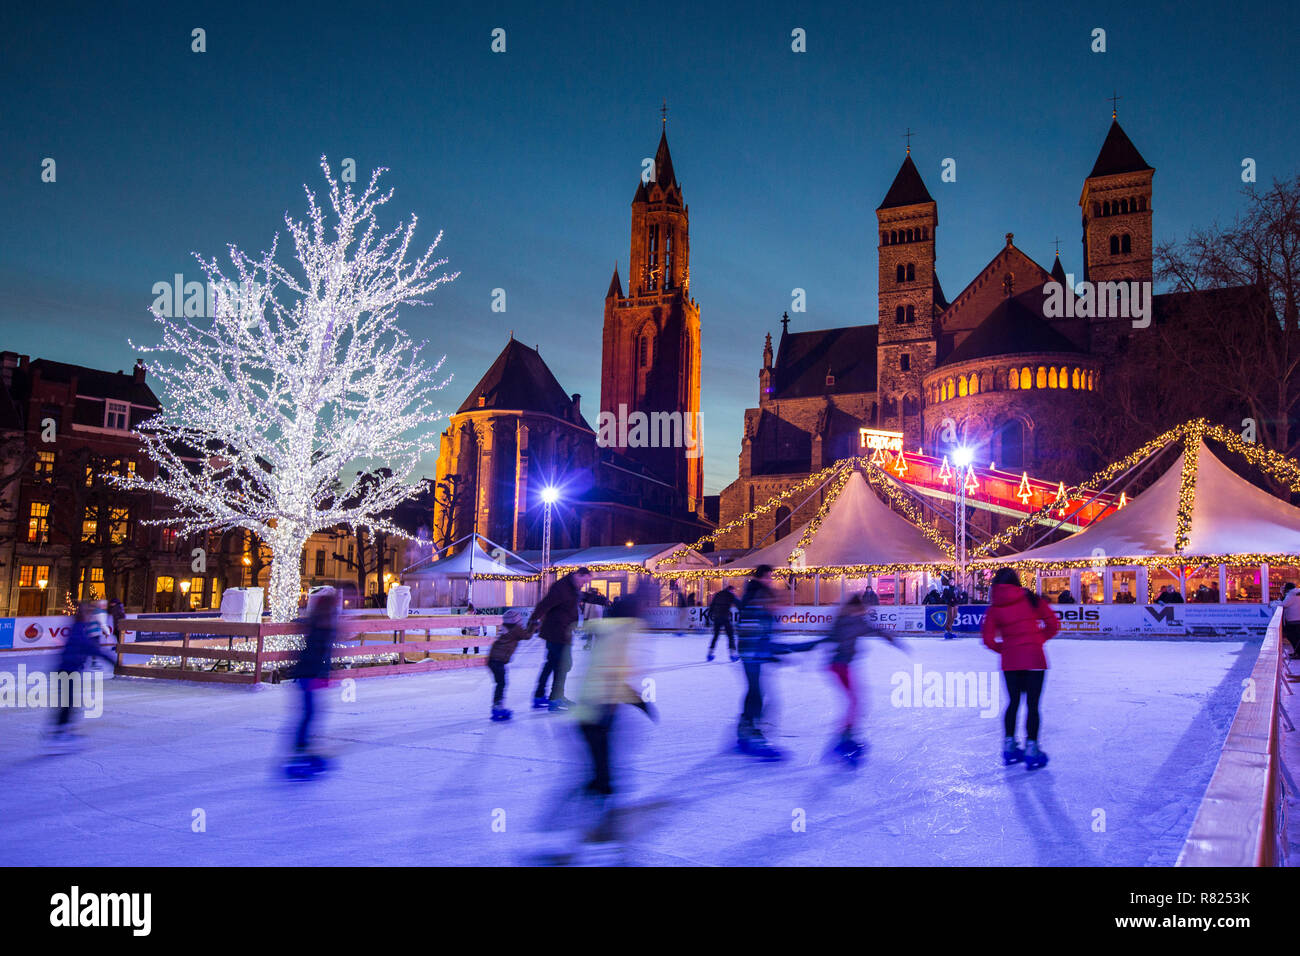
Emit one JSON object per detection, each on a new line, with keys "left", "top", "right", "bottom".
{"left": 723, "top": 471, "right": 952, "bottom": 571}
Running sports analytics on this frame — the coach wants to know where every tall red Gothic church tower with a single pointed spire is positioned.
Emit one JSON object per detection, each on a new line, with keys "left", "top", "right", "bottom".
{"left": 601, "top": 125, "right": 705, "bottom": 511}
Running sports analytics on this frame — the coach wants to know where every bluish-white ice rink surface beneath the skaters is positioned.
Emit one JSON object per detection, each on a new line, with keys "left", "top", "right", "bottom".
{"left": 0, "top": 636, "right": 1258, "bottom": 866}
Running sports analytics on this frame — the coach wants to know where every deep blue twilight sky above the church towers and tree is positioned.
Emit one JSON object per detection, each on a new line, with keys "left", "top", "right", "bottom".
{"left": 0, "top": 0, "right": 1300, "bottom": 493}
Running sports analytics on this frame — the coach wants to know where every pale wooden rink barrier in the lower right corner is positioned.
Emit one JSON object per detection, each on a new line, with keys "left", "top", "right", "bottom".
{"left": 1177, "top": 609, "right": 1287, "bottom": 866}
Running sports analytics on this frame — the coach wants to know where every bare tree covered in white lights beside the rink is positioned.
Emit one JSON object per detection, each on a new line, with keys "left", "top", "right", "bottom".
{"left": 118, "top": 157, "right": 459, "bottom": 622}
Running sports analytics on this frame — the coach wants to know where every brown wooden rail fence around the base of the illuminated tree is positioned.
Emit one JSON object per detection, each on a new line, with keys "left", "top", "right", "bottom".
{"left": 113, "top": 614, "right": 502, "bottom": 684}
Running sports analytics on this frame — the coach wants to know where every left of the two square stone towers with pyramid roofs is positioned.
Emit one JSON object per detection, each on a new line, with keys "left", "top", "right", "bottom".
{"left": 876, "top": 153, "right": 943, "bottom": 445}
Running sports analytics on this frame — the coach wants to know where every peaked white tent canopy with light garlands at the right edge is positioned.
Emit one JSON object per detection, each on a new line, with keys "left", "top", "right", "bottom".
{"left": 980, "top": 442, "right": 1300, "bottom": 564}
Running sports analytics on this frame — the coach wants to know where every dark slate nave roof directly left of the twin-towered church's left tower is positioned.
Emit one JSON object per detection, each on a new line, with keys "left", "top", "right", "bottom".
{"left": 771, "top": 325, "right": 879, "bottom": 399}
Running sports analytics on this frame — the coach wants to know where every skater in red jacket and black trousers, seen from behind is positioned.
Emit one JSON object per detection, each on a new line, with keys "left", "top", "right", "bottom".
{"left": 980, "top": 567, "right": 1061, "bottom": 770}
